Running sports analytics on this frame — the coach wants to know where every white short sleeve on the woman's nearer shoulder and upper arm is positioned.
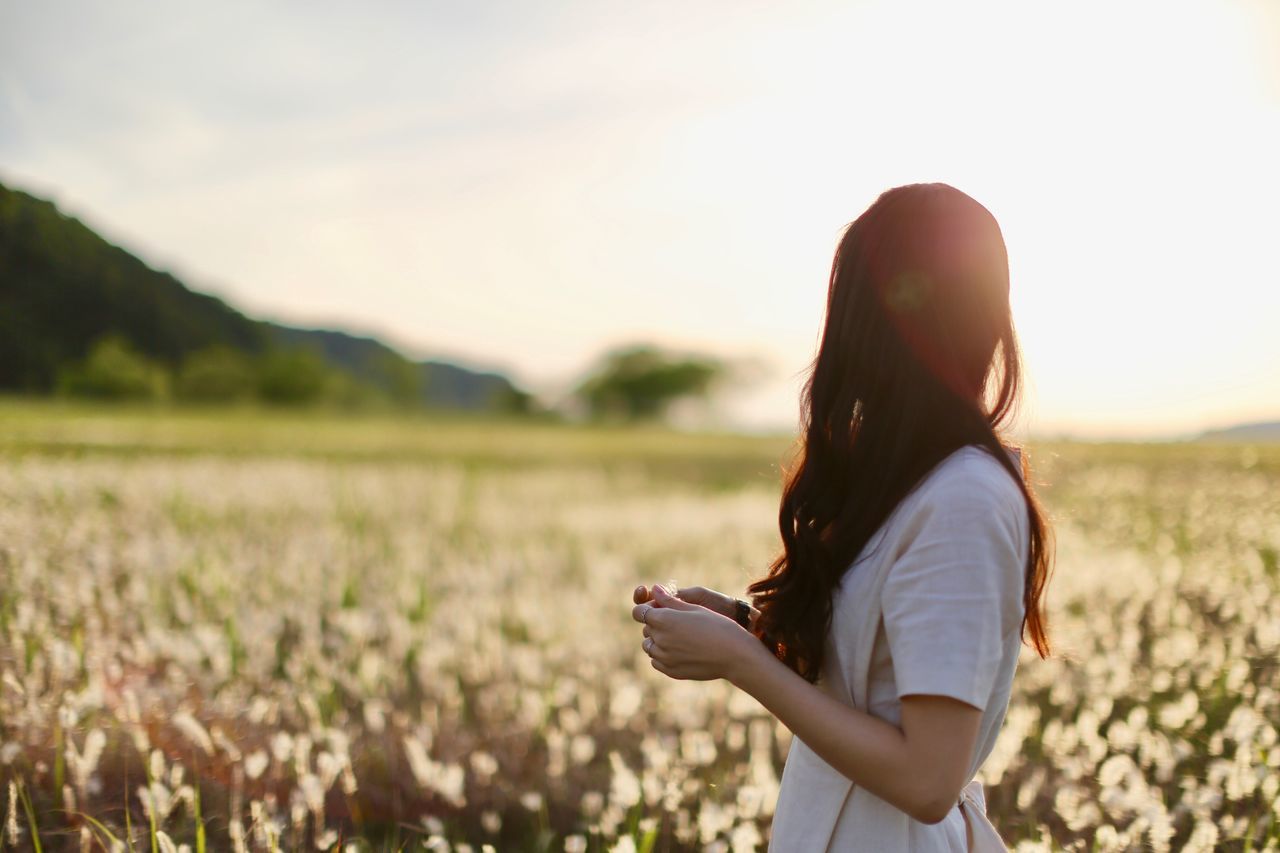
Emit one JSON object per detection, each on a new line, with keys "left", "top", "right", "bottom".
{"left": 881, "top": 451, "right": 1027, "bottom": 710}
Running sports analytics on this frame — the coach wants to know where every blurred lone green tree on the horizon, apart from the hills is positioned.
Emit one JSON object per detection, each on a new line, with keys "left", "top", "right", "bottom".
{"left": 575, "top": 345, "right": 726, "bottom": 420}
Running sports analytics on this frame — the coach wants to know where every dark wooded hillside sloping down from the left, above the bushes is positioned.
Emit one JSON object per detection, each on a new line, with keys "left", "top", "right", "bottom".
{"left": 0, "top": 183, "right": 525, "bottom": 410}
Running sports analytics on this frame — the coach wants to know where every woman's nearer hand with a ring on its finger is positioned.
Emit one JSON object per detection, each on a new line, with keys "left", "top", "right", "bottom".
{"left": 631, "top": 587, "right": 765, "bottom": 681}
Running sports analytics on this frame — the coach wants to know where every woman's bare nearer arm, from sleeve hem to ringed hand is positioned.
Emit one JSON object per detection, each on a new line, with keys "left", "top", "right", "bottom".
{"left": 632, "top": 588, "right": 982, "bottom": 824}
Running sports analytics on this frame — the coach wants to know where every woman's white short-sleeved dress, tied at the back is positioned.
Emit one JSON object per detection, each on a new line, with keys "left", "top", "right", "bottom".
{"left": 771, "top": 446, "right": 1030, "bottom": 853}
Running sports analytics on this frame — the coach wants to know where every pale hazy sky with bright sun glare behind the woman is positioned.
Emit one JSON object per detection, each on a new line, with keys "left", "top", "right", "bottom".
{"left": 0, "top": 0, "right": 1280, "bottom": 438}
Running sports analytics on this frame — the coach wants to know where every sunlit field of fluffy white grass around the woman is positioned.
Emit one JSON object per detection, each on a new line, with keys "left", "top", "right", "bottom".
{"left": 0, "top": 402, "right": 1280, "bottom": 852}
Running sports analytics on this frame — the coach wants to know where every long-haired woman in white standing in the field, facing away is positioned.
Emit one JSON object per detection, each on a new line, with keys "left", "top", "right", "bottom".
{"left": 632, "top": 183, "right": 1051, "bottom": 853}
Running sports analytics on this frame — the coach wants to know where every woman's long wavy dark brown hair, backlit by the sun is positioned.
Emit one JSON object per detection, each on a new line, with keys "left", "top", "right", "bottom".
{"left": 749, "top": 183, "right": 1052, "bottom": 681}
